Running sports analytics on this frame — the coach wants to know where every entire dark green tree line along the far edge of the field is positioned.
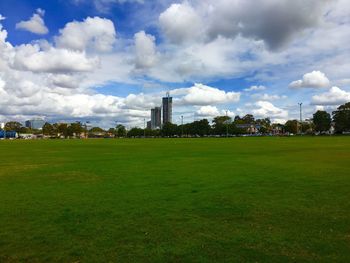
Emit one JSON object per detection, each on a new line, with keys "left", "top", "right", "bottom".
{"left": 5, "top": 102, "right": 350, "bottom": 138}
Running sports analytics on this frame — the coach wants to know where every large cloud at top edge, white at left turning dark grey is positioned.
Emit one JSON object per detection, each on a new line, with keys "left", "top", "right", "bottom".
{"left": 159, "top": 0, "right": 327, "bottom": 50}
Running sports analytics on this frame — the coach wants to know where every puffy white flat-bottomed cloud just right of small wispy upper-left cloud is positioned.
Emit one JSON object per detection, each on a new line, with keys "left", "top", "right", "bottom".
{"left": 55, "top": 17, "right": 116, "bottom": 52}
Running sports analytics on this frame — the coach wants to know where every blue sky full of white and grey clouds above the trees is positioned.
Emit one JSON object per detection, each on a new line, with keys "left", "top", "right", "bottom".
{"left": 0, "top": 0, "right": 350, "bottom": 127}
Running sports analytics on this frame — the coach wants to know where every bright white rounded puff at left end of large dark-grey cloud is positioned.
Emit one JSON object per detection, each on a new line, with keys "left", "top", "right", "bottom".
{"left": 159, "top": 2, "right": 202, "bottom": 44}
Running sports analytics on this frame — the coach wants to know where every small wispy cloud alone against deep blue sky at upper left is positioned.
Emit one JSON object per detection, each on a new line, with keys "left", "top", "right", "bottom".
{"left": 16, "top": 8, "right": 49, "bottom": 35}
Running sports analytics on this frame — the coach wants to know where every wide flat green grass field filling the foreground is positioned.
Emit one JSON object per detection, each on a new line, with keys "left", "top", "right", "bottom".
{"left": 0, "top": 137, "right": 350, "bottom": 262}
